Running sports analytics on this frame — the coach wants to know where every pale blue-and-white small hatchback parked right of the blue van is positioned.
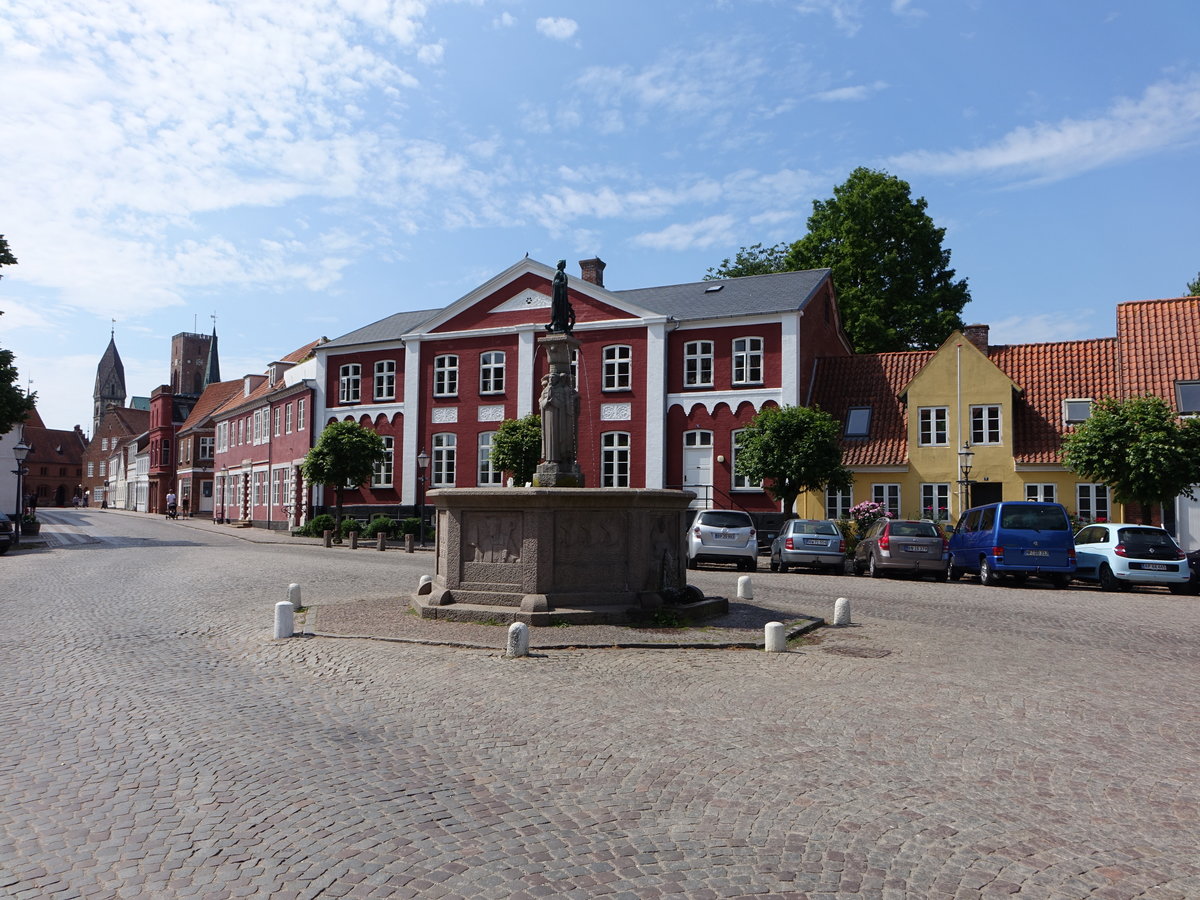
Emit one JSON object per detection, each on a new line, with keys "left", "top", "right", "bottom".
{"left": 1075, "top": 522, "right": 1192, "bottom": 590}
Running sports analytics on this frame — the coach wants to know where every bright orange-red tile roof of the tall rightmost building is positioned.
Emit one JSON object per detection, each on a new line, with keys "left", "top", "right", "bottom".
{"left": 1117, "top": 296, "right": 1200, "bottom": 409}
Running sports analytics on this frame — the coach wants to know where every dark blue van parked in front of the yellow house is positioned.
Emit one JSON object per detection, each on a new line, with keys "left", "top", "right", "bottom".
{"left": 946, "top": 500, "right": 1075, "bottom": 588}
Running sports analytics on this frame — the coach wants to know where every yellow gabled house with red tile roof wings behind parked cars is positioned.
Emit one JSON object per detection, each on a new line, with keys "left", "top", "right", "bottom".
{"left": 797, "top": 325, "right": 1123, "bottom": 523}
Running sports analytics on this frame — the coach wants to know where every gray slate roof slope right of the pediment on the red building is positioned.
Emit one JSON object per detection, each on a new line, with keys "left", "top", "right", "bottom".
{"left": 613, "top": 269, "right": 829, "bottom": 319}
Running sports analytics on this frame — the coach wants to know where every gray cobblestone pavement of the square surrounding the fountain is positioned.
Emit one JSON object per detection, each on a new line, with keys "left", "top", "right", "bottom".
{"left": 0, "top": 510, "right": 1200, "bottom": 900}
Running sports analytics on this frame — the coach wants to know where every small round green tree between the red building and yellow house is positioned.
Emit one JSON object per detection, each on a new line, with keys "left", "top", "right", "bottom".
{"left": 737, "top": 407, "right": 852, "bottom": 515}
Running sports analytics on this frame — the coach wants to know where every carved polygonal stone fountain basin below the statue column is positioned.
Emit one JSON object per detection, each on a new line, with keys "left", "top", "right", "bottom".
{"left": 413, "top": 487, "right": 728, "bottom": 625}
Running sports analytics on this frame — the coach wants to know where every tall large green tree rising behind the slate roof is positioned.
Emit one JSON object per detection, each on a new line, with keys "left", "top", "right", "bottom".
{"left": 787, "top": 168, "right": 971, "bottom": 353}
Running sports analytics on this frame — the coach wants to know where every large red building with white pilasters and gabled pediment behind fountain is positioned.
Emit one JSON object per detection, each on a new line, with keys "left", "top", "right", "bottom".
{"left": 316, "top": 259, "right": 850, "bottom": 517}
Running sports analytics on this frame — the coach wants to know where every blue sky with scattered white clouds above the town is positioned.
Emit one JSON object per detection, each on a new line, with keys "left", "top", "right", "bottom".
{"left": 0, "top": 0, "right": 1200, "bottom": 432}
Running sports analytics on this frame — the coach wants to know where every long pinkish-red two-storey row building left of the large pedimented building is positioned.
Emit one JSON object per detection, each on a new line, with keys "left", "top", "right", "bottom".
{"left": 211, "top": 338, "right": 325, "bottom": 528}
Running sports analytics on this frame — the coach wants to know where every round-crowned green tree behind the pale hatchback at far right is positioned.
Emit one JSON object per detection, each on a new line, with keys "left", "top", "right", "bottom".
{"left": 1062, "top": 395, "right": 1200, "bottom": 528}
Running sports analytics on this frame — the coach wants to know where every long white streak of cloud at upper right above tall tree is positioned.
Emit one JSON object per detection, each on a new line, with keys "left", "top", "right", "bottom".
{"left": 887, "top": 76, "right": 1200, "bottom": 182}
